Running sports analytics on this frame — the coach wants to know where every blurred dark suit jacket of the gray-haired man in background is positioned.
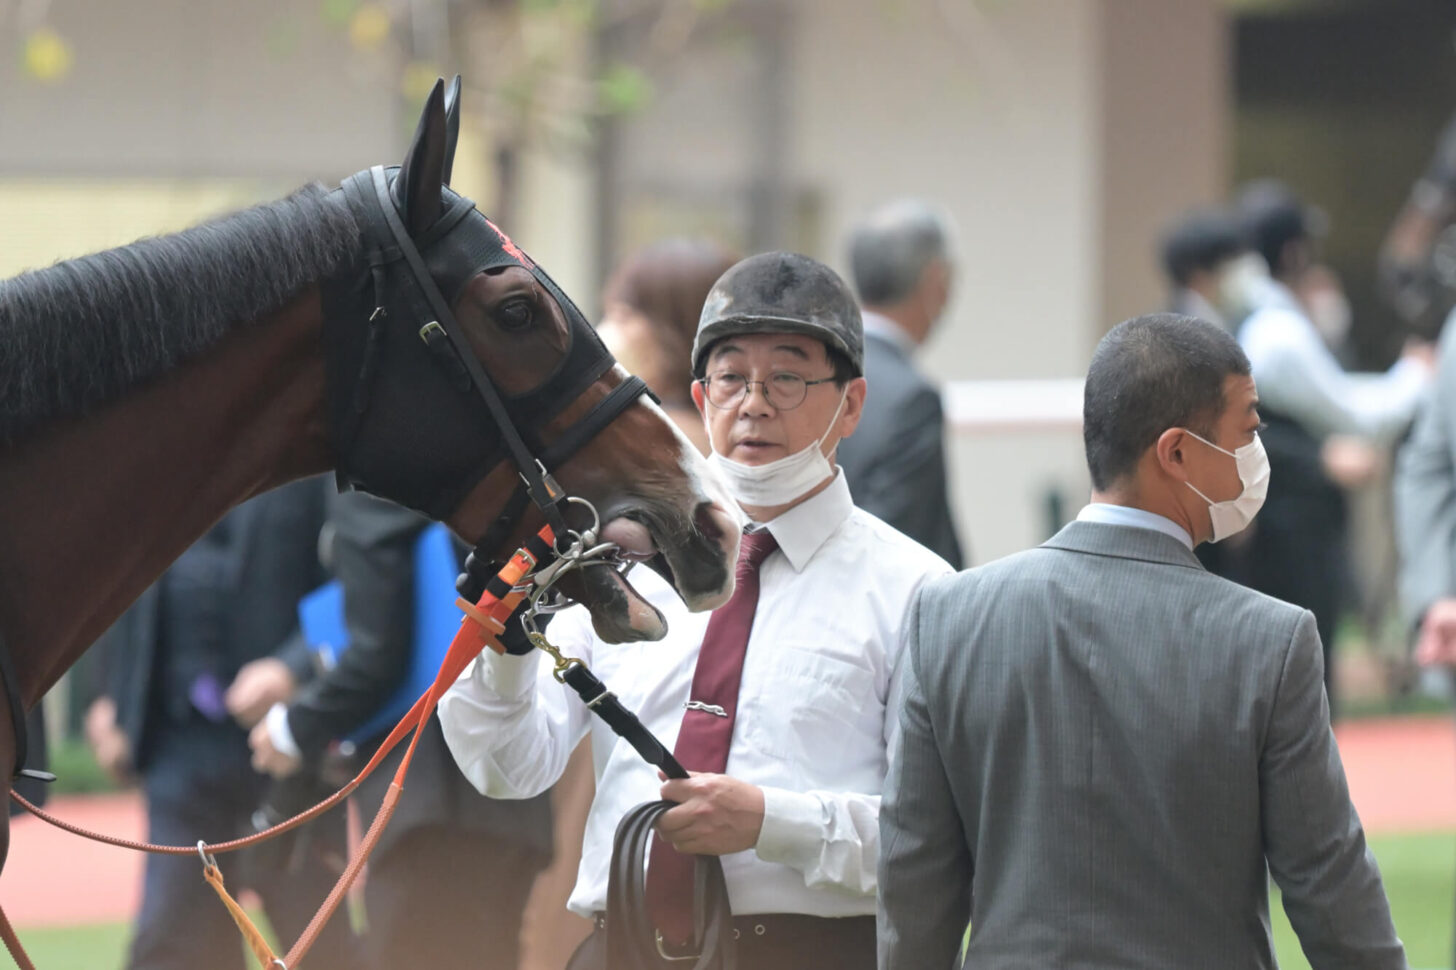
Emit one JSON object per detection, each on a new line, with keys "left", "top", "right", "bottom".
{"left": 836, "top": 312, "right": 964, "bottom": 569}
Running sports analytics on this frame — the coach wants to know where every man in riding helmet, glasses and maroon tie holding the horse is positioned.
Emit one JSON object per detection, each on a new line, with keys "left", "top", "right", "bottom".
{"left": 440, "top": 252, "right": 951, "bottom": 970}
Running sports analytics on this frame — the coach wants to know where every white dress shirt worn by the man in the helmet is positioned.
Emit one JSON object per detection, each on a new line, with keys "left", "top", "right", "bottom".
{"left": 440, "top": 473, "right": 951, "bottom": 916}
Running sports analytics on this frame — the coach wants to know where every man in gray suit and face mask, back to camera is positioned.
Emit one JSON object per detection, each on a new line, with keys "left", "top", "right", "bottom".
{"left": 879, "top": 313, "right": 1405, "bottom": 970}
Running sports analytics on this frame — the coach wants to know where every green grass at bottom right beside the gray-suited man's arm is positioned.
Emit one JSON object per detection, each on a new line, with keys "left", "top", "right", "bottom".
{"left": 1270, "top": 832, "right": 1456, "bottom": 970}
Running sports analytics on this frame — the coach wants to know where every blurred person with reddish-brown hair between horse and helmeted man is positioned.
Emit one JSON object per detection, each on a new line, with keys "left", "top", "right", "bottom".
{"left": 597, "top": 239, "right": 738, "bottom": 454}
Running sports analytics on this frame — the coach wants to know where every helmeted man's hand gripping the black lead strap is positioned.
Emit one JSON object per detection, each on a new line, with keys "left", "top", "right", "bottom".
{"left": 657, "top": 772, "right": 763, "bottom": 855}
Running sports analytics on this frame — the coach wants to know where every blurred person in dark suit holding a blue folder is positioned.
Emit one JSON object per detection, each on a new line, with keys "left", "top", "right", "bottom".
{"left": 249, "top": 492, "right": 552, "bottom": 970}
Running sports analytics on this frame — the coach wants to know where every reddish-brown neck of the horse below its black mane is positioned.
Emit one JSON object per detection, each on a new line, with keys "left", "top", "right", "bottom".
{"left": 0, "top": 288, "right": 331, "bottom": 706}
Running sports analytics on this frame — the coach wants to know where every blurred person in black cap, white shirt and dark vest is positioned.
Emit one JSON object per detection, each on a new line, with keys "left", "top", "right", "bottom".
{"left": 1229, "top": 181, "right": 1431, "bottom": 709}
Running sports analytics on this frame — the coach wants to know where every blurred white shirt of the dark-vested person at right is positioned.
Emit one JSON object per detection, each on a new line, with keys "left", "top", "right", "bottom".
{"left": 1239, "top": 283, "right": 1428, "bottom": 443}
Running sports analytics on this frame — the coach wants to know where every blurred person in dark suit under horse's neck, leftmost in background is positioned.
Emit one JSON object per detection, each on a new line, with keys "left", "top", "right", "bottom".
{"left": 86, "top": 478, "right": 354, "bottom": 970}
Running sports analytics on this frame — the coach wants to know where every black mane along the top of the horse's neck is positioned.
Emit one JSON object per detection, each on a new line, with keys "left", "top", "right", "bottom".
{"left": 0, "top": 185, "right": 358, "bottom": 443}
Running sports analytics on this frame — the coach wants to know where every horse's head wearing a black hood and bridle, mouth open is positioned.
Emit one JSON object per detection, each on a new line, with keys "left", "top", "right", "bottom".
{"left": 322, "top": 77, "right": 738, "bottom": 641}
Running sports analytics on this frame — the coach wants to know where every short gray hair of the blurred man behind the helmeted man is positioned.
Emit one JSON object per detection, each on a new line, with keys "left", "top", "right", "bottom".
{"left": 849, "top": 198, "right": 952, "bottom": 306}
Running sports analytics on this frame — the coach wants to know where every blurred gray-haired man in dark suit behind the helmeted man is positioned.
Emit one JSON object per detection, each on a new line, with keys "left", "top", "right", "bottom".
{"left": 837, "top": 200, "right": 962, "bottom": 569}
